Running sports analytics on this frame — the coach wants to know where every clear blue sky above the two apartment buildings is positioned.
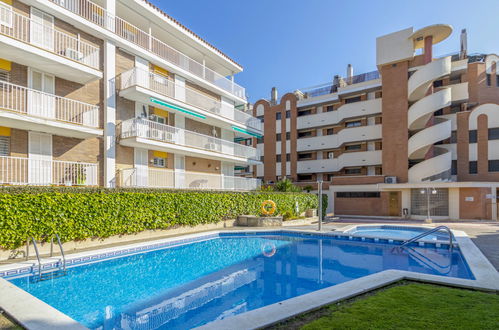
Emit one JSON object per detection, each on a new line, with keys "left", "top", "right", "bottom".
{"left": 151, "top": 0, "right": 499, "bottom": 102}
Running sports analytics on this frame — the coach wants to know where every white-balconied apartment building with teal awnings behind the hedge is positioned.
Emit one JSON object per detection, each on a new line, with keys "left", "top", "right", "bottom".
{"left": 0, "top": 0, "right": 263, "bottom": 190}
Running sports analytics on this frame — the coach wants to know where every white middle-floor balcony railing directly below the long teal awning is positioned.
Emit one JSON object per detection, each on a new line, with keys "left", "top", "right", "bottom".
{"left": 120, "top": 118, "right": 259, "bottom": 160}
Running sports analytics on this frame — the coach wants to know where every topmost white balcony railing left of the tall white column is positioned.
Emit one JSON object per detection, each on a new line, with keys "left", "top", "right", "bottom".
{"left": 0, "top": 7, "right": 100, "bottom": 70}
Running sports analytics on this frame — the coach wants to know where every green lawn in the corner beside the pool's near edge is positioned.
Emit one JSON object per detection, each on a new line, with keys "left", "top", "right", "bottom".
{"left": 277, "top": 283, "right": 499, "bottom": 330}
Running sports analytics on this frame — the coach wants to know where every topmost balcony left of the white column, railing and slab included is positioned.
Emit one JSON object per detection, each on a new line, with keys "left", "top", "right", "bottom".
{"left": 0, "top": 7, "right": 102, "bottom": 84}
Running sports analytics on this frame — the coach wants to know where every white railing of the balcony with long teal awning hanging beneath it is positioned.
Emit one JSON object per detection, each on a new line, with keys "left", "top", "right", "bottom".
{"left": 119, "top": 68, "right": 263, "bottom": 131}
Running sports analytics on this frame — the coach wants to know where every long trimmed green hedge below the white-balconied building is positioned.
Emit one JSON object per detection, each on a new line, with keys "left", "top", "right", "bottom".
{"left": 0, "top": 187, "right": 317, "bottom": 249}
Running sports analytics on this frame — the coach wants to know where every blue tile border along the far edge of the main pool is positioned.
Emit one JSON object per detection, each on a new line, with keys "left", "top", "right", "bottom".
{"left": 0, "top": 231, "right": 459, "bottom": 279}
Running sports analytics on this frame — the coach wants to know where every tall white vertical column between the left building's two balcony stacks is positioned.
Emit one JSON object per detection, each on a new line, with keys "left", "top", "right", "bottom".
{"left": 104, "top": 0, "right": 116, "bottom": 188}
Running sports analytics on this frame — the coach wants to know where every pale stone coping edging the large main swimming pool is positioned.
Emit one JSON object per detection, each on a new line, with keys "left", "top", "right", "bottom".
{"left": 0, "top": 228, "right": 499, "bottom": 329}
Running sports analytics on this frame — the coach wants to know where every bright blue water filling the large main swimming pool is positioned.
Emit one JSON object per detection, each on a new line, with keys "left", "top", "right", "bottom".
{"left": 11, "top": 233, "right": 473, "bottom": 329}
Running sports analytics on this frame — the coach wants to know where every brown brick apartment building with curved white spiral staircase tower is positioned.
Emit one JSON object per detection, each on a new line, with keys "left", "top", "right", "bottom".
{"left": 253, "top": 25, "right": 499, "bottom": 220}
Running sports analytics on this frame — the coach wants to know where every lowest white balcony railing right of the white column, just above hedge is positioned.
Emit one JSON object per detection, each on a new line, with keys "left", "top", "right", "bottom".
{"left": 119, "top": 168, "right": 261, "bottom": 191}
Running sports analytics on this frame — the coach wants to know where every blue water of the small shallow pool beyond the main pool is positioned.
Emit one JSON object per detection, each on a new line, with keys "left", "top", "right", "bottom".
{"left": 348, "top": 225, "right": 449, "bottom": 241}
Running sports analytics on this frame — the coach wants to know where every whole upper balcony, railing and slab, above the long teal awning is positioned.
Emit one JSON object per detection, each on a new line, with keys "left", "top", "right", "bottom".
{"left": 118, "top": 68, "right": 263, "bottom": 134}
